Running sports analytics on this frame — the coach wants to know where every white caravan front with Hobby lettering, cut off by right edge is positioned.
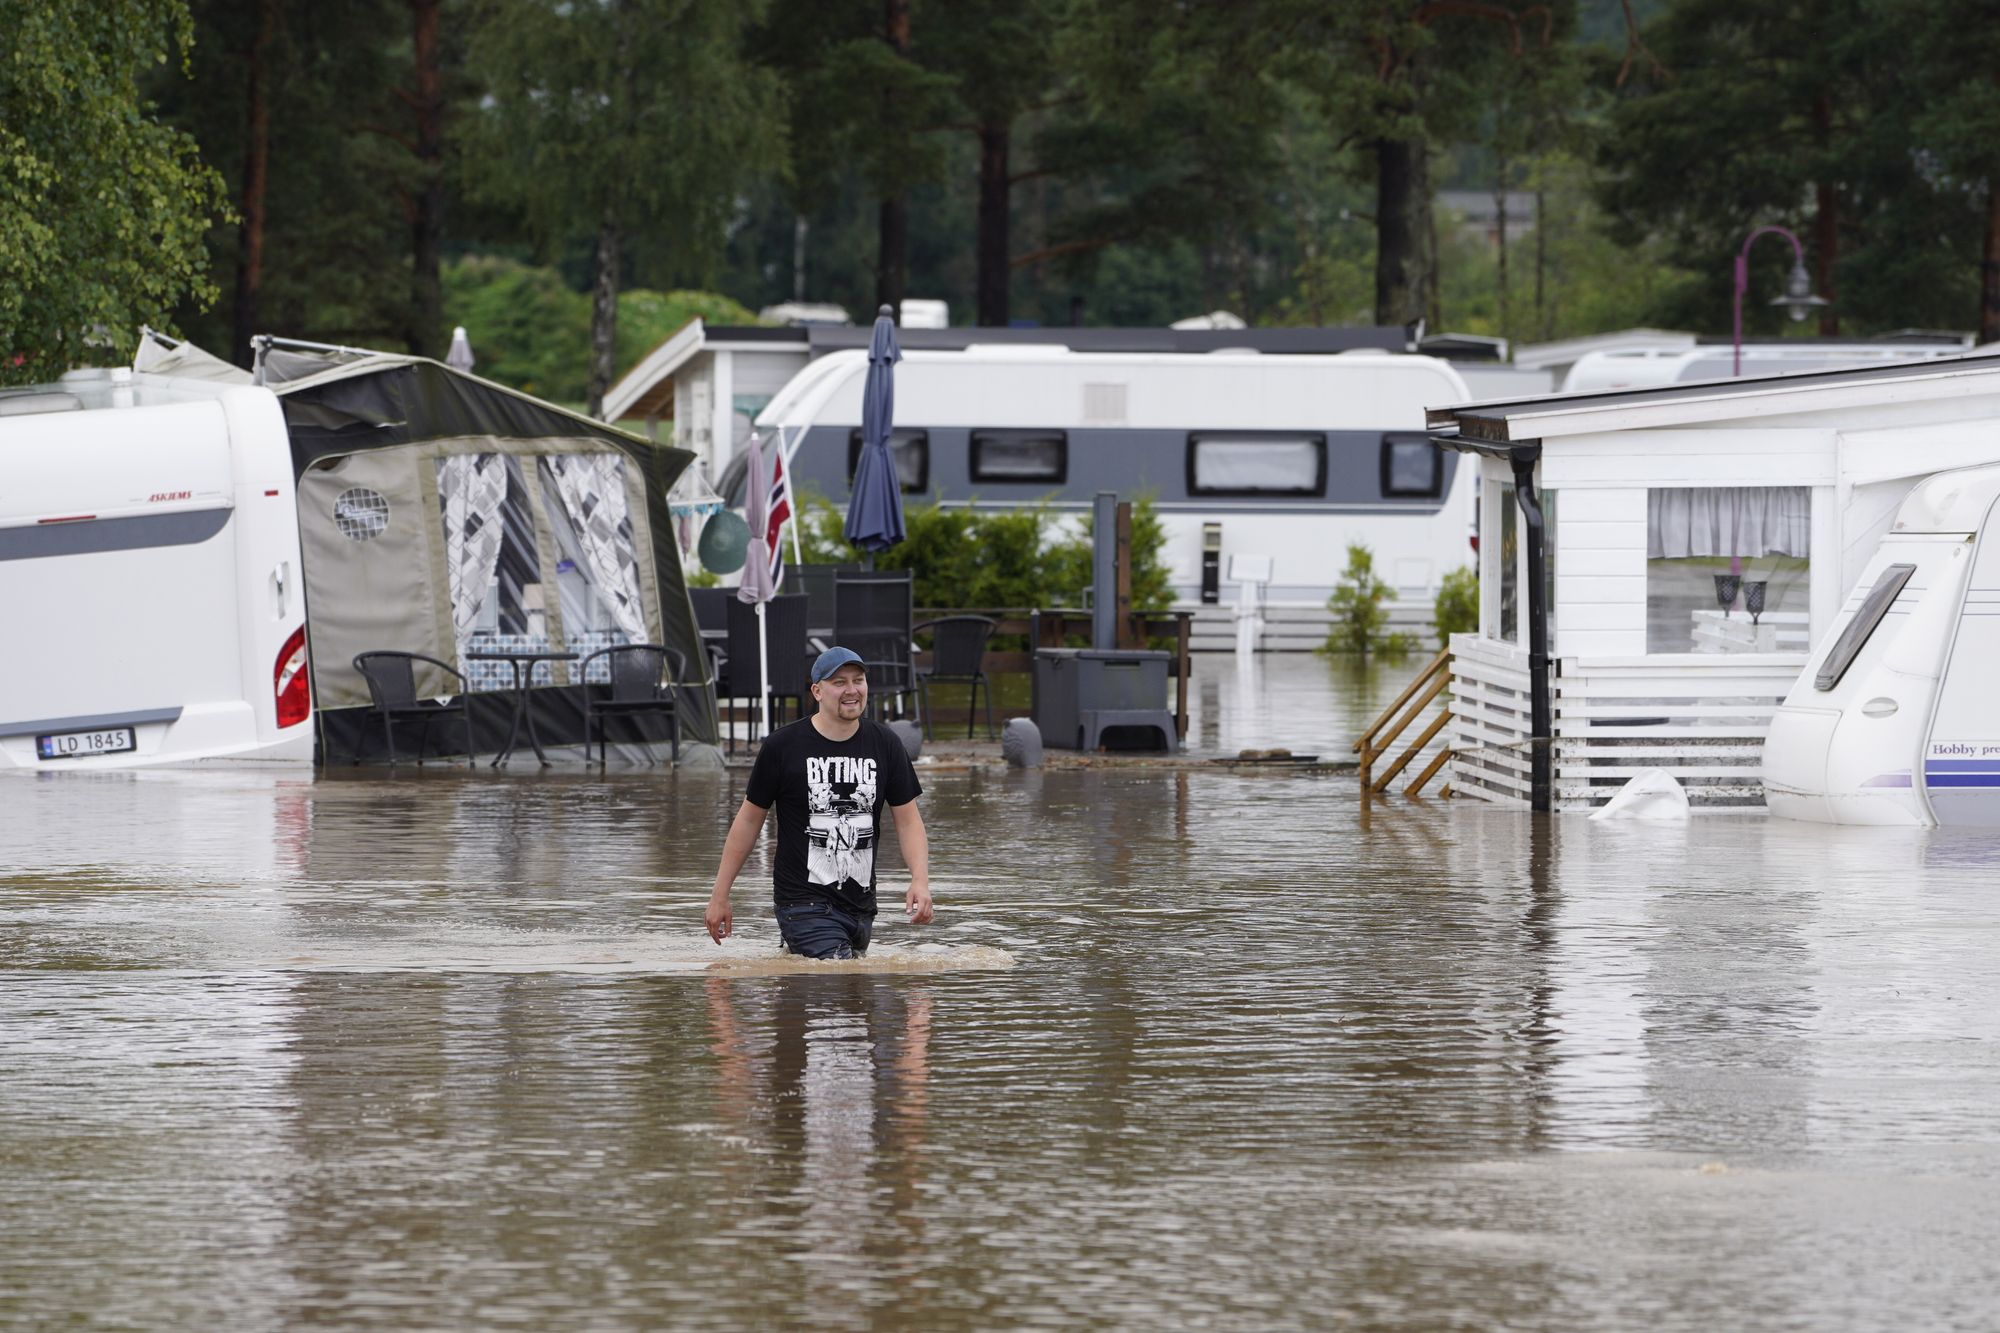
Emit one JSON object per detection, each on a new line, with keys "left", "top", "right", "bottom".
{"left": 1764, "top": 464, "right": 2000, "bottom": 827}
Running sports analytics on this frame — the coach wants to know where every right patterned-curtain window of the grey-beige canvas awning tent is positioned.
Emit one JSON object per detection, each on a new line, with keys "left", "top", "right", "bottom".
{"left": 538, "top": 454, "right": 648, "bottom": 681}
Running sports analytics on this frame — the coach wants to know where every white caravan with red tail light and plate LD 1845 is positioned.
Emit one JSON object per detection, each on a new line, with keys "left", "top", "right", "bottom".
{"left": 0, "top": 370, "right": 312, "bottom": 773}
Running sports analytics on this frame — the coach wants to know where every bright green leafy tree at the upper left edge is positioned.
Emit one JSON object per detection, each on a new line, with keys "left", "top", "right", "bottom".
{"left": 0, "top": 0, "right": 226, "bottom": 382}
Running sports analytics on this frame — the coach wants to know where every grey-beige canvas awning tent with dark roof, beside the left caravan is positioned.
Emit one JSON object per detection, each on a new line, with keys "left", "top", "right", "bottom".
{"left": 140, "top": 340, "right": 716, "bottom": 763}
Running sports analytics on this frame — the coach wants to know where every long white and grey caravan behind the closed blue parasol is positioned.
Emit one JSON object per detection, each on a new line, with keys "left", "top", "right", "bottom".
{"left": 744, "top": 344, "right": 1476, "bottom": 608}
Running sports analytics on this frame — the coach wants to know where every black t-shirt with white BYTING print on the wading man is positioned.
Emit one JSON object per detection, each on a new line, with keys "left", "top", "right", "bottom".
{"left": 744, "top": 717, "right": 924, "bottom": 913}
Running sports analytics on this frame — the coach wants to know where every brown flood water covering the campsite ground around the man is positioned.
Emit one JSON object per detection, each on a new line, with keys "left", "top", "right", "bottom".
{"left": 0, "top": 656, "right": 2000, "bottom": 1331}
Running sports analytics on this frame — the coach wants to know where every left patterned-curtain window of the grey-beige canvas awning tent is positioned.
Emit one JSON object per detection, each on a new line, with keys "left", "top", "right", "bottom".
{"left": 438, "top": 454, "right": 548, "bottom": 691}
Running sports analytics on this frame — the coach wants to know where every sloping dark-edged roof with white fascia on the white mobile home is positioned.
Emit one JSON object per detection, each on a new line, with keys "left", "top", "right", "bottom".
{"left": 1428, "top": 348, "right": 2000, "bottom": 452}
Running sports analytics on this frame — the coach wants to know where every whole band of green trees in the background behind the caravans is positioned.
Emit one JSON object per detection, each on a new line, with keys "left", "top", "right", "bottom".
{"left": 23, "top": 0, "right": 2000, "bottom": 386}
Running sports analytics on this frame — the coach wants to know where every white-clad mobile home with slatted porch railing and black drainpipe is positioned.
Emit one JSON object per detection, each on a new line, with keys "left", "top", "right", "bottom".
{"left": 1430, "top": 356, "right": 2000, "bottom": 809}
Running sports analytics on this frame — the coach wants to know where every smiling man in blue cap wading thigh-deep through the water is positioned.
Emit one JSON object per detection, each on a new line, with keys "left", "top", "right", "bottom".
{"left": 706, "top": 648, "right": 930, "bottom": 959}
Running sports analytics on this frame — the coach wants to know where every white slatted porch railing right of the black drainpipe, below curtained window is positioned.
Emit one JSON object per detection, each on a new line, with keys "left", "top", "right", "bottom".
{"left": 1552, "top": 652, "right": 1806, "bottom": 811}
